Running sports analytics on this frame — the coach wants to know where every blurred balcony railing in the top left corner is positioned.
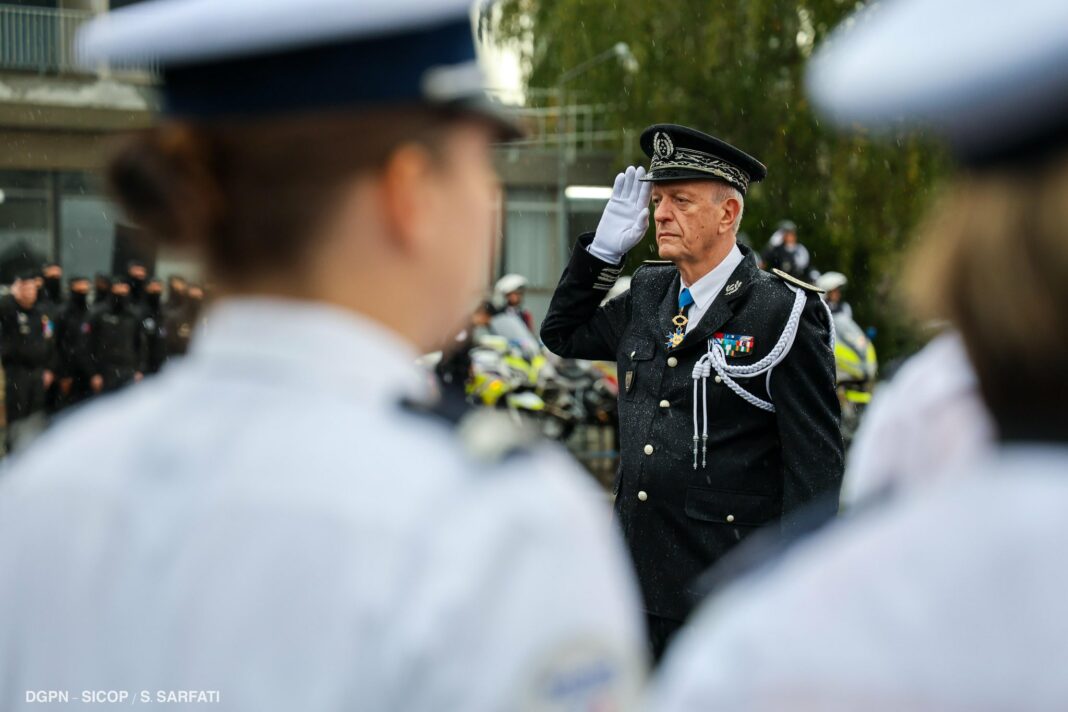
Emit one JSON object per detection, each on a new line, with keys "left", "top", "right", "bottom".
{"left": 0, "top": 4, "right": 156, "bottom": 75}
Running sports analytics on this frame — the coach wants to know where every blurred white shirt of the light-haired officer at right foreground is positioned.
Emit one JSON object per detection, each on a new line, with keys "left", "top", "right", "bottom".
{"left": 648, "top": 446, "right": 1068, "bottom": 712}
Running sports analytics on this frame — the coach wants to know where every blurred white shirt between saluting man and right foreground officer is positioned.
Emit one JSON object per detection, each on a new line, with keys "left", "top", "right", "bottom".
{"left": 842, "top": 332, "right": 994, "bottom": 507}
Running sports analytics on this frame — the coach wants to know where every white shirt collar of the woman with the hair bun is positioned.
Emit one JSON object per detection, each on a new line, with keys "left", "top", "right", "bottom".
{"left": 190, "top": 297, "right": 429, "bottom": 401}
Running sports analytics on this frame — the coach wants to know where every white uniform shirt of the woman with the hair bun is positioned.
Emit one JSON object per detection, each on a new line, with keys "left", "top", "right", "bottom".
{"left": 0, "top": 300, "right": 644, "bottom": 712}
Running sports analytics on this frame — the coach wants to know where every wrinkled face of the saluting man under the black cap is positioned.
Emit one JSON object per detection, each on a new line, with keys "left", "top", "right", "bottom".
{"left": 653, "top": 180, "right": 723, "bottom": 263}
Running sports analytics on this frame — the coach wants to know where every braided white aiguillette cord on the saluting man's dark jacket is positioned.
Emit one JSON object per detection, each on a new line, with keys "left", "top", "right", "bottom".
{"left": 693, "top": 285, "right": 835, "bottom": 470}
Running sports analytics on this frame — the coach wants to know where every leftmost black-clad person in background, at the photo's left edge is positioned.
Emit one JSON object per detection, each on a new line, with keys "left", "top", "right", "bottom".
{"left": 0, "top": 270, "right": 54, "bottom": 453}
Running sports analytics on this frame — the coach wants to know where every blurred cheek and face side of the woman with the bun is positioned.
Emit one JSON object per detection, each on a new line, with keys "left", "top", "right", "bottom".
{"left": 426, "top": 122, "right": 498, "bottom": 323}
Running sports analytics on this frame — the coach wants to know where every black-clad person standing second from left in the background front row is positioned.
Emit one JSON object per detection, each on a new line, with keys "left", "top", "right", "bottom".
{"left": 56, "top": 276, "right": 96, "bottom": 407}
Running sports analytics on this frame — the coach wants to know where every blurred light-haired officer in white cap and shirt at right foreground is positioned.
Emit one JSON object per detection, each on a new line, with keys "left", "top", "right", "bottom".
{"left": 650, "top": 0, "right": 1068, "bottom": 712}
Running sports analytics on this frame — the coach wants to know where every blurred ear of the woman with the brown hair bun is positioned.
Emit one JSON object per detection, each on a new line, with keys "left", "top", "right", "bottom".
{"left": 379, "top": 143, "right": 443, "bottom": 253}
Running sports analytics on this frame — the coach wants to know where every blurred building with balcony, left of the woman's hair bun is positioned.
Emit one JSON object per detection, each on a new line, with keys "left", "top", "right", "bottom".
{"left": 0, "top": 0, "right": 157, "bottom": 283}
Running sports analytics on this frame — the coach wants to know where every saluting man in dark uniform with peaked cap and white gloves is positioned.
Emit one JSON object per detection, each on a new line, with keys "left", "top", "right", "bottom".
{"left": 541, "top": 124, "right": 843, "bottom": 656}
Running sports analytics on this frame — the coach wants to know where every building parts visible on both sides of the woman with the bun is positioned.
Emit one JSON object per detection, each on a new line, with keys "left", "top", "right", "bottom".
{"left": 0, "top": 0, "right": 619, "bottom": 321}
